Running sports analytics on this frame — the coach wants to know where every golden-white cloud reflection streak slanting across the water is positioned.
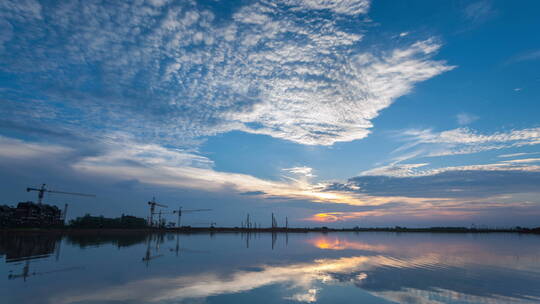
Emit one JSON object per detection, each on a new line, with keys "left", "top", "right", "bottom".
{"left": 51, "top": 256, "right": 380, "bottom": 304}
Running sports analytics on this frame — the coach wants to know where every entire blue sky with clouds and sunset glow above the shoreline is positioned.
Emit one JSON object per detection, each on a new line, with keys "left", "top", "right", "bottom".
{"left": 0, "top": 0, "right": 540, "bottom": 227}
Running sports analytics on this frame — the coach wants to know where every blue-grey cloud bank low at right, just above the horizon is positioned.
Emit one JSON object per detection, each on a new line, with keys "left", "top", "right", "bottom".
{"left": 312, "top": 165, "right": 540, "bottom": 226}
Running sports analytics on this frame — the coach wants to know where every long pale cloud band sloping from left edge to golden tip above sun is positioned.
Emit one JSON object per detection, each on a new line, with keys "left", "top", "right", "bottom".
{"left": 0, "top": 134, "right": 372, "bottom": 205}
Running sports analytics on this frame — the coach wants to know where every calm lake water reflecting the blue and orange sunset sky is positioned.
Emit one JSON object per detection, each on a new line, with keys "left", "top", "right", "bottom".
{"left": 0, "top": 233, "right": 540, "bottom": 304}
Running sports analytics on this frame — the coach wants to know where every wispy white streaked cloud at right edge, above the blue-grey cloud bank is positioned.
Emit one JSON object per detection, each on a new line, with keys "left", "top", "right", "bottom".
{"left": 361, "top": 128, "right": 540, "bottom": 177}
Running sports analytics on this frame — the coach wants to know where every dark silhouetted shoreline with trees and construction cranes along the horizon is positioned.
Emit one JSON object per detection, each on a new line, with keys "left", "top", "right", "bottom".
{"left": 0, "top": 184, "right": 540, "bottom": 234}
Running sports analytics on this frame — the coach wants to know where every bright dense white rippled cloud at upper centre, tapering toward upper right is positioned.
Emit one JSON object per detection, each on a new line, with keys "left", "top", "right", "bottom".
{"left": 236, "top": 40, "right": 451, "bottom": 145}
